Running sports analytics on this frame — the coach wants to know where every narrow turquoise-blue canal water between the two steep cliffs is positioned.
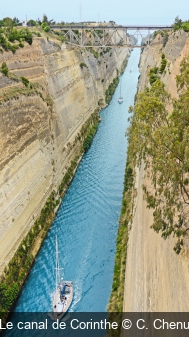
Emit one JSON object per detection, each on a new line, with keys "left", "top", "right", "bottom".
{"left": 15, "top": 48, "right": 140, "bottom": 312}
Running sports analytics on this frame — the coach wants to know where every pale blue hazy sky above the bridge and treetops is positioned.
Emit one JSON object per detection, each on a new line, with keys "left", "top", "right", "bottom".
{"left": 0, "top": 0, "right": 189, "bottom": 25}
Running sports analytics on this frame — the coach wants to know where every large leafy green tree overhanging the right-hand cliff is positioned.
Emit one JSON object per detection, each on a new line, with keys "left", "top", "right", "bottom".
{"left": 128, "top": 58, "right": 189, "bottom": 254}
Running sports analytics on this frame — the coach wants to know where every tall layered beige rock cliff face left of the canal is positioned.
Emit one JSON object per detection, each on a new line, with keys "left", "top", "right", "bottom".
{"left": 0, "top": 38, "right": 129, "bottom": 271}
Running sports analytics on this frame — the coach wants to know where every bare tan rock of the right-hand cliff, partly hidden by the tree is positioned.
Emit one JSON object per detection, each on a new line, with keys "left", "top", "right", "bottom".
{"left": 123, "top": 31, "right": 189, "bottom": 312}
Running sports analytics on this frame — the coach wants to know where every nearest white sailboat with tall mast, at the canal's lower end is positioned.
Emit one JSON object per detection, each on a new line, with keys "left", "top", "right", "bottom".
{"left": 53, "top": 236, "right": 74, "bottom": 320}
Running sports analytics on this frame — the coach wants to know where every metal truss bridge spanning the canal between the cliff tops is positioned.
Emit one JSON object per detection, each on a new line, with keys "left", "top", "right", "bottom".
{"left": 50, "top": 24, "right": 173, "bottom": 48}
